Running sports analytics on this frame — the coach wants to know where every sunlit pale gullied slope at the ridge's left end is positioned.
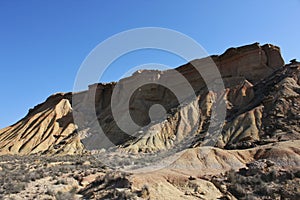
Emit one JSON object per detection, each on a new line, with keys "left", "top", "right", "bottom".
{"left": 0, "top": 93, "right": 83, "bottom": 155}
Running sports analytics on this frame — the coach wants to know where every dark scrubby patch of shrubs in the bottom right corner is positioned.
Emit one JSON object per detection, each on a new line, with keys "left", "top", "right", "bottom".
{"left": 223, "top": 161, "right": 300, "bottom": 199}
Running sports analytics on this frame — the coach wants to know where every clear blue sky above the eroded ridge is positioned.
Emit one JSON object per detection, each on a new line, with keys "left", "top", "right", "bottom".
{"left": 0, "top": 0, "right": 300, "bottom": 128}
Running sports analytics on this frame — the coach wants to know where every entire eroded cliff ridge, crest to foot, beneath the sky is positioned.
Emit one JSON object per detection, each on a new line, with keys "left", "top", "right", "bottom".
{"left": 0, "top": 43, "right": 292, "bottom": 154}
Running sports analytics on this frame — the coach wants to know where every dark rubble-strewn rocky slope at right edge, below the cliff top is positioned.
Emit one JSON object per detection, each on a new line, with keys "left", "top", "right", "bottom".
{"left": 221, "top": 61, "right": 300, "bottom": 148}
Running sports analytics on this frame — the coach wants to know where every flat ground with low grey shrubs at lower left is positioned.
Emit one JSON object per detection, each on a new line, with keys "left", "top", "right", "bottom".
{"left": 0, "top": 155, "right": 104, "bottom": 200}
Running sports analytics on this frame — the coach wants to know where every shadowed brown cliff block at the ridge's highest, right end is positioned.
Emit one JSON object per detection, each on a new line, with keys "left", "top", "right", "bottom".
{"left": 214, "top": 43, "right": 284, "bottom": 83}
